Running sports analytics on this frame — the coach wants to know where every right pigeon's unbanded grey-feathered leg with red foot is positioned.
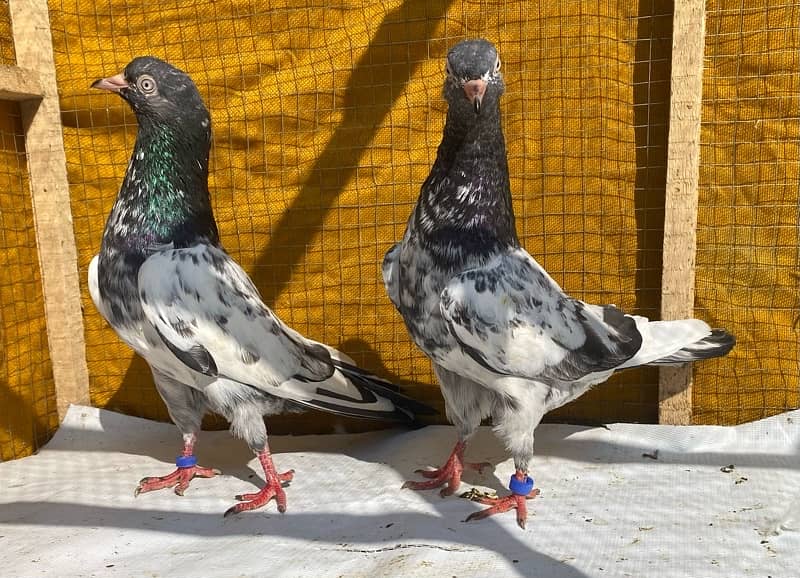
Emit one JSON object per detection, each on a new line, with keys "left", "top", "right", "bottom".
{"left": 402, "top": 364, "right": 493, "bottom": 498}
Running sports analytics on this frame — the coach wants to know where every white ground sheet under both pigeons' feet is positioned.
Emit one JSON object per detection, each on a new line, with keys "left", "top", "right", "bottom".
{"left": 0, "top": 406, "right": 800, "bottom": 578}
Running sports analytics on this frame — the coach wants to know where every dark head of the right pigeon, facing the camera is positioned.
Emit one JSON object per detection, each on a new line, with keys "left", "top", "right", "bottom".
{"left": 444, "top": 38, "right": 505, "bottom": 116}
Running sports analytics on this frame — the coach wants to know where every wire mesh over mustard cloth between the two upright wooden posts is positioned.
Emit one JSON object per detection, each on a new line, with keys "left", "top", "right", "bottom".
{"left": 51, "top": 0, "right": 671, "bottom": 431}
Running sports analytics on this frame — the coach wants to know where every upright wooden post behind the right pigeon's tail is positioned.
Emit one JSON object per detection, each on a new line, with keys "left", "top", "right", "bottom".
{"left": 659, "top": 0, "right": 706, "bottom": 424}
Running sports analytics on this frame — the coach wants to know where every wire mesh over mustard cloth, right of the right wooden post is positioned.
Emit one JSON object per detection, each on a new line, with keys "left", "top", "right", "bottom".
{"left": 694, "top": 2, "right": 800, "bottom": 424}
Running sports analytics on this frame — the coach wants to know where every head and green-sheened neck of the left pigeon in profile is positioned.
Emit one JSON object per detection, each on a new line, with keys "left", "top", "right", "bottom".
{"left": 92, "top": 56, "right": 218, "bottom": 251}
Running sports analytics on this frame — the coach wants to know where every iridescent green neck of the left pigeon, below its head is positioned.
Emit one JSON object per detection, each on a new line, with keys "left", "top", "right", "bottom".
{"left": 103, "top": 120, "right": 219, "bottom": 253}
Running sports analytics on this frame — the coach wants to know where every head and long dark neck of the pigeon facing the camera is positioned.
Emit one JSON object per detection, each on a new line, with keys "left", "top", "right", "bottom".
{"left": 409, "top": 39, "right": 519, "bottom": 258}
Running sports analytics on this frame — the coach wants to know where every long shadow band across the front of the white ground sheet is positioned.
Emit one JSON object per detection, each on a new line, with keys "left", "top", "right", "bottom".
{"left": 0, "top": 501, "right": 587, "bottom": 578}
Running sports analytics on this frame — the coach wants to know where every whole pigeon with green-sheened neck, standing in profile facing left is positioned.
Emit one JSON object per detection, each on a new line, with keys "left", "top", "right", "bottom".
{"left": 89, "top": 56, "right": 433, "bottom": 515}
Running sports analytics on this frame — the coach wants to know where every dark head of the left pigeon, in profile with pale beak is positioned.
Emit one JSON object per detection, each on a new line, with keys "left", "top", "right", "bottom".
{"left": 92, "top": 56, "right": 211, "bottom": 131}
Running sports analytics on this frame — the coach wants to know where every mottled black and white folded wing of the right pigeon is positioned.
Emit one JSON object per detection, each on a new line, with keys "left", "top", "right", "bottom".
{"left": 441, "top": 249, "right": 642, "bottom": 382}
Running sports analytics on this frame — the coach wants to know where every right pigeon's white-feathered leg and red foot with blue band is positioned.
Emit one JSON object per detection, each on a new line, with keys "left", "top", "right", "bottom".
{"left": 464, "top": 380, "right": 545, "bottom": 530}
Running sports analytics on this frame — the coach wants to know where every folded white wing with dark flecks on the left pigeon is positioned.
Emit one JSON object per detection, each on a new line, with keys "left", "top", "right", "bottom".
{"left": 139, "top": 245, "right": 406, "bottom": 419}
